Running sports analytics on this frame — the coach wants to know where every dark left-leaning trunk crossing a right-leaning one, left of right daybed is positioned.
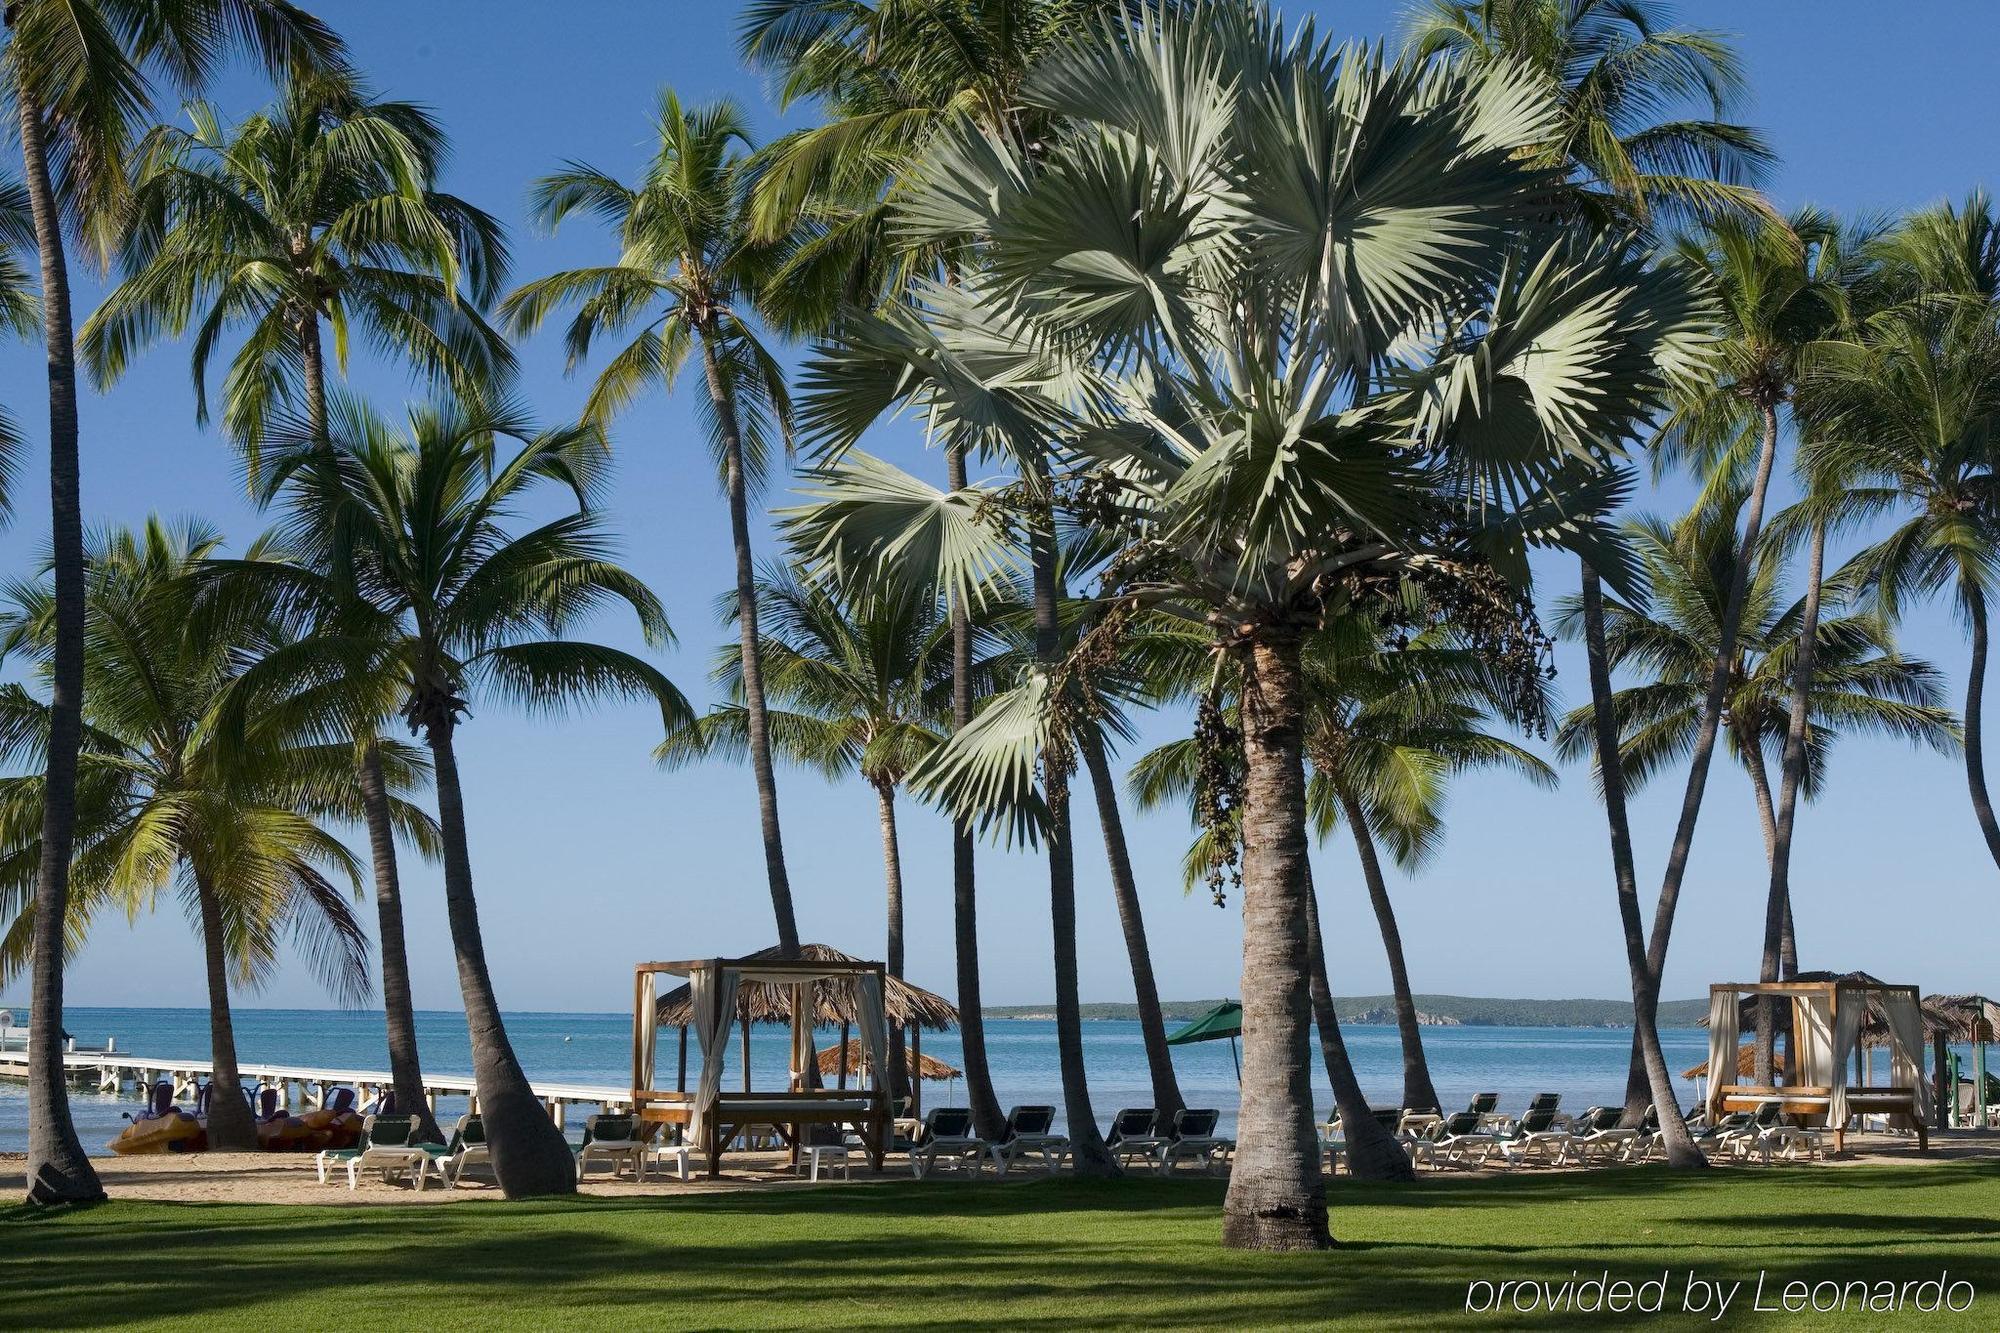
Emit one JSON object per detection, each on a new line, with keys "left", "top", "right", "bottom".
{"left": 1584, "top": 560, "right": 1708, "bottom": 1169}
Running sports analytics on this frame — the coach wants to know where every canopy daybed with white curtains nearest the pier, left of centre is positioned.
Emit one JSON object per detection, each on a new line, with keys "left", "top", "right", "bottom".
{"left": 632, "top": 957, "right": 890, "bottom": 1175}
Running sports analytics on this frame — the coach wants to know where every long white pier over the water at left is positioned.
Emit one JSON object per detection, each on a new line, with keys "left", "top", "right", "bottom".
{"left": 0, "top": 1043, "right": 632, "bottom": 1125}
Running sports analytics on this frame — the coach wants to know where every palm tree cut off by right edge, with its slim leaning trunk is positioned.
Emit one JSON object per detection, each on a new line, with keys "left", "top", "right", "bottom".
{"left": 1806, "top": 194, "right": 2000, "bottom": 865}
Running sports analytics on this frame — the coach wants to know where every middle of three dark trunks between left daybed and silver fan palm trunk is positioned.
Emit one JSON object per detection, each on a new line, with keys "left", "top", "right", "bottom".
{"left": 1030, "top": 488, "right": 1118, "bottom": 1177}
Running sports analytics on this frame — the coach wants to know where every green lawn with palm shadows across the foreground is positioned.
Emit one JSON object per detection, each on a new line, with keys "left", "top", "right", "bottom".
{"left": 0, "top": 1163, "right": 2000, "bottom": 1329}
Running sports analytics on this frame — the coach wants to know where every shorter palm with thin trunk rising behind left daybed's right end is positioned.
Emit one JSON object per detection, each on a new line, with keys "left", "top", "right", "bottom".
{"left": 654, "top": 568, "right": 950, "bottom": 1085}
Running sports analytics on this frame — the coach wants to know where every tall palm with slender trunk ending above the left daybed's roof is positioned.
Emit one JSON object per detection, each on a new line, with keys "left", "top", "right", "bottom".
{"left": 502, "top": 90, "right": 798, "bottom": 957}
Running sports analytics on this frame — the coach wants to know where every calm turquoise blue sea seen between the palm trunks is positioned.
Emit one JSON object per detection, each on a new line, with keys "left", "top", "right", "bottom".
{"left": 0, "top": 1009, "right": 1736, "bottom": 1153}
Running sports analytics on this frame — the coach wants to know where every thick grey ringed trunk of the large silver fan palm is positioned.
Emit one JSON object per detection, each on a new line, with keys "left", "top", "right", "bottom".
{"left": 1222, "top": 626, "right": 1334, "bottom": 1249}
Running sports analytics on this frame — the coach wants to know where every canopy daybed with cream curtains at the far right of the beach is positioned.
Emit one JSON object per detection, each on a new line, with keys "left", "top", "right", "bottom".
{"left": 1706, "top": 973, "right": 1932, "bottom": 1151}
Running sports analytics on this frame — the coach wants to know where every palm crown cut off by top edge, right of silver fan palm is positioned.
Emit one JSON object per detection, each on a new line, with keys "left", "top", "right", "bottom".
{"left": 1406, "top": 0, "right": 1776, "bottom": 226}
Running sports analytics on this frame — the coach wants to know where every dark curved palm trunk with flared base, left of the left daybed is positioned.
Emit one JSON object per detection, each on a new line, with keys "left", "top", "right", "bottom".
{"left": 424, "top": 705, "right": 576, "bottom": 1199}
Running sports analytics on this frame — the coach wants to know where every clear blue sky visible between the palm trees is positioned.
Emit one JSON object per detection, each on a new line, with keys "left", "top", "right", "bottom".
{"left": 0, "top": 0, "right": 2000, "bottom": 1009}
